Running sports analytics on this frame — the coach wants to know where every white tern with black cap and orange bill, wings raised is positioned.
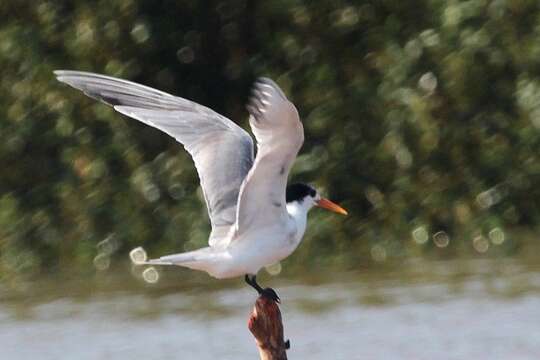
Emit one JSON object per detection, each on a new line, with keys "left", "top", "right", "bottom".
{"left": 54, "top": 70, "right": 347, "bottom": 302}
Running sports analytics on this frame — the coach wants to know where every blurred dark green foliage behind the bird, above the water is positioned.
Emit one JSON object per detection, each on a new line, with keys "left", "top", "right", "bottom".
{"left": 0, "top": 0, "right": 540, "bottom": 275}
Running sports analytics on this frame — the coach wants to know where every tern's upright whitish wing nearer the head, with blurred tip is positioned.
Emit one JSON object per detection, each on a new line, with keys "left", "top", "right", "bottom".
{"left": 236, "top": 78, "right": 304, "bottom": 234}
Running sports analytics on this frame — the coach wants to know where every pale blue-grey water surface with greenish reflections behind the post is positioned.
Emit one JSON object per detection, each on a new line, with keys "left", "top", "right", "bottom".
{"left": 0, "top": 260, "right": 540, "bottom": 359}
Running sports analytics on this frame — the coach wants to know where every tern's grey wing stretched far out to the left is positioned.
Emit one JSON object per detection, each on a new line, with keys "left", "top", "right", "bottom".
{"left": 54, "top": 70, "right": 253, "bottom": 246}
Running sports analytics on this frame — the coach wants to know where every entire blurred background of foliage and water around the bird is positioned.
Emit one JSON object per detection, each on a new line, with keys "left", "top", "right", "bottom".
{"left": 0, "top": 0, "right": 540, "bottom": 359}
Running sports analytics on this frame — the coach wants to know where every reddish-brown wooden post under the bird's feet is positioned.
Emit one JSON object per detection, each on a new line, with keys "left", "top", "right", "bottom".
{"left": 248, "top": 296, "right": 290, "bottom": 360}
